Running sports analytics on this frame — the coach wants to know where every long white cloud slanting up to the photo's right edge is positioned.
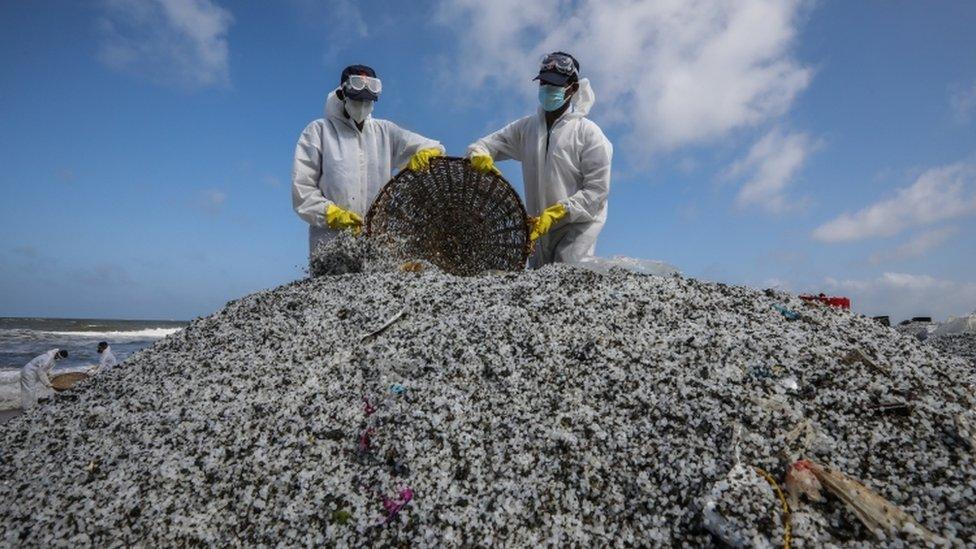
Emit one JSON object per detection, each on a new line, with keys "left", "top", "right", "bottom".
{"left": 813, "top": 162, "right": 976, "bottom": 242}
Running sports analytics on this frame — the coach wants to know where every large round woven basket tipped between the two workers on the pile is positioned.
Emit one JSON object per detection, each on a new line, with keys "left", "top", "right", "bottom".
{"left": 366, "top": 157, "right": 531, "bottom": 276}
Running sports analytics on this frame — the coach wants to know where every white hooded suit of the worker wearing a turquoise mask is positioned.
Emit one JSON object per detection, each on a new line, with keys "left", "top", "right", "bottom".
{"left": 468, "top": 78, "right": 613, "bottom": 267}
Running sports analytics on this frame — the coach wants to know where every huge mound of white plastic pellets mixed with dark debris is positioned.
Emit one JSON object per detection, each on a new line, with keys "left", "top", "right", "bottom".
{"left": 0, "top": 241, "right": 976, "bottom": 547}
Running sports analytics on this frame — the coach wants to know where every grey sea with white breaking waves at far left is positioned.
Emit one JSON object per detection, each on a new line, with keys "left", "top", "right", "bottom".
{"left": 0, "top": 317, "right": 188, "bottom": 410}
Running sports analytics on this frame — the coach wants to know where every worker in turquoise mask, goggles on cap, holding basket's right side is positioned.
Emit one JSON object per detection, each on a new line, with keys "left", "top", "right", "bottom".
{"left": 468, "top": 52, "right": 613, "bottom": 268}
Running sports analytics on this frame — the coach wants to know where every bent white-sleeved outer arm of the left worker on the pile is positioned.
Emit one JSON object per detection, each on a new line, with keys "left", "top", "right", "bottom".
{"left": 291, "top": 120, "right": 332, "bottom": 227}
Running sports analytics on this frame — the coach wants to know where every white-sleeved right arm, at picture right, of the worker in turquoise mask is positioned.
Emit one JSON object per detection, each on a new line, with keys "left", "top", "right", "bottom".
{"left": 560, "top": 122, "right": 613, "bottom": 223}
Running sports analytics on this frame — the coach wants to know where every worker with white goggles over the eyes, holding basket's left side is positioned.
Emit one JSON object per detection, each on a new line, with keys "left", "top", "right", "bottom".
{"left": 291, "top": 65, "right": 444, "bottom": 259}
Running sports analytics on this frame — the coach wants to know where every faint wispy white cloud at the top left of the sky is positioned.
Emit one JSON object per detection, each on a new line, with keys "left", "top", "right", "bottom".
{"left": 99, "top": 0, "right": 234, "bottom": 89}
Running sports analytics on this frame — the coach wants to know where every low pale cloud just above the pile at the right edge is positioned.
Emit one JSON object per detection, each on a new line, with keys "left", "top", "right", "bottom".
{"left": 824, "top": 272, "right": 976, "bottom": 321}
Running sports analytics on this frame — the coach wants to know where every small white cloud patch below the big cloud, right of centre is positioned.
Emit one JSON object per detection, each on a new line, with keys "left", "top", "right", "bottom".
{"left": 730, "top": 128, "right": 819, "bottom": 213}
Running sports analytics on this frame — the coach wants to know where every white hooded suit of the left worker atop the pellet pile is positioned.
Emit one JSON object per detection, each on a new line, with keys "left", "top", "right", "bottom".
{"left": 291, "top": 91, "right": 444, "bottom": 256}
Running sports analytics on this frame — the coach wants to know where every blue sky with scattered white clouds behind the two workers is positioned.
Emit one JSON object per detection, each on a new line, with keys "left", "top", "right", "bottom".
{"left": 0, "top": 0, "right": 976, "bottom": 319}
